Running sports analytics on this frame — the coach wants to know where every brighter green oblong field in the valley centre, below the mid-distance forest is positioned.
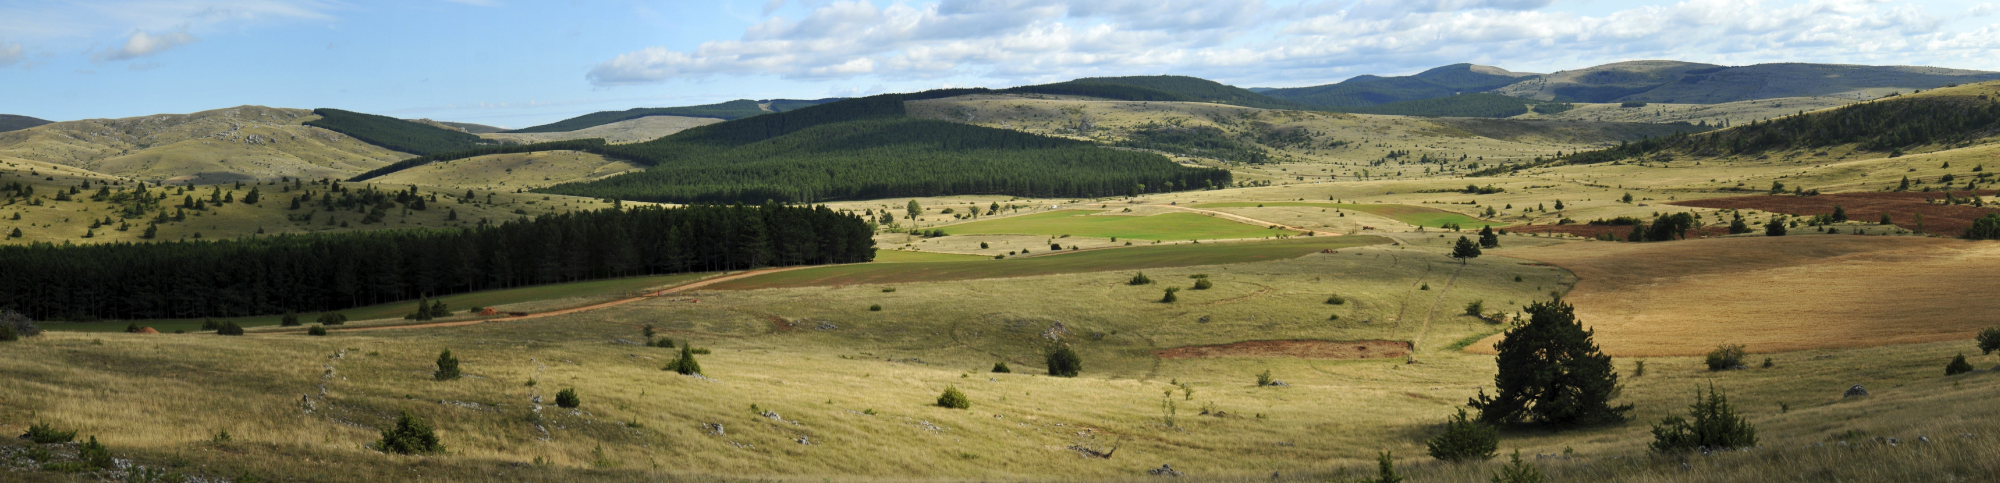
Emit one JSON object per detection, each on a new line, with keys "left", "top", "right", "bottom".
{"left": 944, "top": 210, "right": 1272, "bottom": 240}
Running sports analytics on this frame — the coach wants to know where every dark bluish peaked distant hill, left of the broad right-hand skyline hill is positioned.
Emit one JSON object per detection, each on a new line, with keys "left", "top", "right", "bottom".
{"left": 1262, "top": 64, "right": 1538, "bottom": 108}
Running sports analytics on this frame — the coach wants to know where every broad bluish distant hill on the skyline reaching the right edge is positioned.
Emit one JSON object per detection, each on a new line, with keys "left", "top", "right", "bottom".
{"left": 1494, "top": 60, "right": 2000, "bottom": 104}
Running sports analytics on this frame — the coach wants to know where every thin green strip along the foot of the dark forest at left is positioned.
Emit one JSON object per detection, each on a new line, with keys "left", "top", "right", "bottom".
{"left": 44, "top": 271, "right": 714, "bottom": 331}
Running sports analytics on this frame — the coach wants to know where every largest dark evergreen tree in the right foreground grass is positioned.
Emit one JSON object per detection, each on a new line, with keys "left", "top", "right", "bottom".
{"left": 1468, "top": 299, "right": 1632, "bottom": 427}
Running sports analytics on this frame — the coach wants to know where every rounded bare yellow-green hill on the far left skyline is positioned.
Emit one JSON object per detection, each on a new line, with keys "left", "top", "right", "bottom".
{"left": 0, "top": 106, "right": 416, "bottom": 184}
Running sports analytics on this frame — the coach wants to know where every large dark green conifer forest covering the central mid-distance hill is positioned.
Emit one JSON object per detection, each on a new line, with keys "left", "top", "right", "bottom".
{"left": 354, "top": 90, "right": 1230, "bottom": 204}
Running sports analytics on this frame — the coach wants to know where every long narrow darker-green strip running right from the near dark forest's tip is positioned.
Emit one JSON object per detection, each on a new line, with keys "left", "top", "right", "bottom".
{"left": 710, "top": 236, "right": 1388, "bottom": 289}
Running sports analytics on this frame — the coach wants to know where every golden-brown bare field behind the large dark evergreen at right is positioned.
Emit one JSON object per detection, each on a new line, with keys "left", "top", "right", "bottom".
{"left": 1466, "top": 236, "right": 2000, "bottom": 357}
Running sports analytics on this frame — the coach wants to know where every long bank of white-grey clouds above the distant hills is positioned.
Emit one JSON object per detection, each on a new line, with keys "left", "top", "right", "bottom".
{"left": 586, "top": 0, "right": 2000, "bottom": 86}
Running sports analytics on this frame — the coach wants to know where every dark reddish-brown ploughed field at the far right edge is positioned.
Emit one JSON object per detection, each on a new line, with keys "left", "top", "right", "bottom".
{"left": 1672, "top": 190, "right": 2000, "bottom": 236}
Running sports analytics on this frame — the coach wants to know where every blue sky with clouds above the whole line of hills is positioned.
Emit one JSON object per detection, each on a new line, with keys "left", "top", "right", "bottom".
{"left": 0, "top": 0, "right": 2000, "bottom": 128}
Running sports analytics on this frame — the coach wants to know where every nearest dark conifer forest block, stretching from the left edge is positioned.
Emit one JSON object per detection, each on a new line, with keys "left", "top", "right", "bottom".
{"left": 0, "top": 204, "right": 874, "bottom": 319}
